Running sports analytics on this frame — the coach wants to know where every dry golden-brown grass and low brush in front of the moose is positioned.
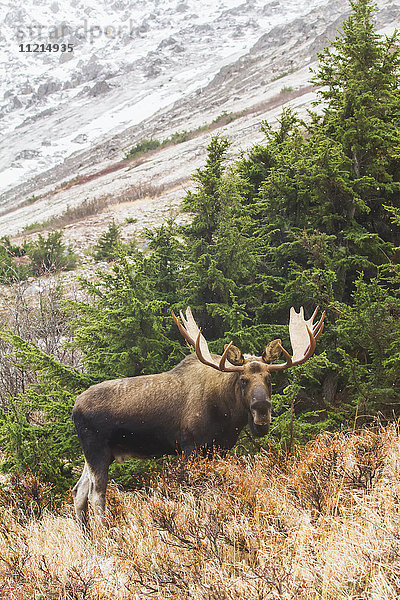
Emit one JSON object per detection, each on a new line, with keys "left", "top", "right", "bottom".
{"left": 0, "top": 426, "right": 400, "bottom": 600}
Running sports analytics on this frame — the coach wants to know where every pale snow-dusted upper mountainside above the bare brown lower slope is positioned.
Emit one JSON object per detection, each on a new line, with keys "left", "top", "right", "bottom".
{"left": 0, "top": 0, "right": 328, "bottom": 192}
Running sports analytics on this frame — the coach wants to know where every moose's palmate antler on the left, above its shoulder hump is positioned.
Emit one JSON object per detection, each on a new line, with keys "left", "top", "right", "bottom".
{"left": 172, "top": 306, "right": 243, "bottom": 372}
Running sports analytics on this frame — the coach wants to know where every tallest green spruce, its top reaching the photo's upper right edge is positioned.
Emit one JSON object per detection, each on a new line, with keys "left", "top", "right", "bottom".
{"left": 313, "top": 0, "right": 400, "bottom": 237}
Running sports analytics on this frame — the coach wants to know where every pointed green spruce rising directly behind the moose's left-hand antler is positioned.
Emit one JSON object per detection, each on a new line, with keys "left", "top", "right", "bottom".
{"left": 182, "top": 137, "right": 257, "bottom": 347}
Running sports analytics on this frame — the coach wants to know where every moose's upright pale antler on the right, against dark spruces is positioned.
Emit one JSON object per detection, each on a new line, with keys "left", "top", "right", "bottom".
{"left": 269, "top": 306, "right": 325, "bottom": 371}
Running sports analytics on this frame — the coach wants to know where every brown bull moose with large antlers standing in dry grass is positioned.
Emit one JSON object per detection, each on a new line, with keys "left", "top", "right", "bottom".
{"left": 72, "top": 307, "right": 325, "bottom": 523}
